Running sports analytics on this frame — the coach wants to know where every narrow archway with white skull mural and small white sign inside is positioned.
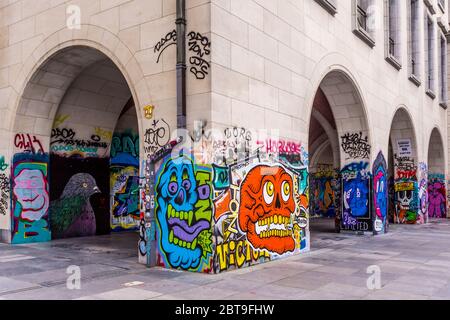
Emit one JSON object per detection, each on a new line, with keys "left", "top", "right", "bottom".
{"left": 388, "top": 107, "right": 420, "bottom": 224}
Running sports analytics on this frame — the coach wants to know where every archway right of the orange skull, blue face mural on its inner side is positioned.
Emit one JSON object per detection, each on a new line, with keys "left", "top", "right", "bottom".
{"left": 309, "top": 70, "right": 373, "bottom": 232}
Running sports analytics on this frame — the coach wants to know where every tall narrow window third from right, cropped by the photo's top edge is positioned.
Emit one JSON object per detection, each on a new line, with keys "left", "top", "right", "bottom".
{"left": 408, "top": 0, "right": 421, "bottom": 86}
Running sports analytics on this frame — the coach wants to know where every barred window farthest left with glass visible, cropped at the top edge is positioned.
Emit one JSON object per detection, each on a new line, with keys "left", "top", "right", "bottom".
{"left": 352, "top": 0, "right": 375, "bottom": 48}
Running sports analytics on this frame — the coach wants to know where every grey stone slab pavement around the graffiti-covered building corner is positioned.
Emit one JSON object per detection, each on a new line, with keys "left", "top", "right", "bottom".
{"left": 0, "top": 220, "right": 450, "bottom": 300}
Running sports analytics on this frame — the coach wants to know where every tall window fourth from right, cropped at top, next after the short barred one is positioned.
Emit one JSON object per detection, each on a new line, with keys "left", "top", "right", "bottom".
{"left": 385, "top": 0, "right": 402, "bottom": 70}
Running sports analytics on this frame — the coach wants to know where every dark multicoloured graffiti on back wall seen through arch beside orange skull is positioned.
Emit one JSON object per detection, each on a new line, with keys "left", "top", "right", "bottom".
{"left": 309, "top": 165, "right": 339, "bottom": 218}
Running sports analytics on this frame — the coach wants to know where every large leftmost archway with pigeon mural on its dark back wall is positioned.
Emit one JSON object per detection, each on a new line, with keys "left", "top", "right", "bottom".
{"left": 11, "top": 46, "right": 140, "bottom": 243}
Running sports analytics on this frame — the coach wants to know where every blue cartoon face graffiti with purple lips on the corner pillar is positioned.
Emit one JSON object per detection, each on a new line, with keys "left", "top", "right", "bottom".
{"left": 156, "top": 157, "right": 212, "bottom": 270}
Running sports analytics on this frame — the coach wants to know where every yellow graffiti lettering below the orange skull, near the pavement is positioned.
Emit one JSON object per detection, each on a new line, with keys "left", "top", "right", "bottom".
{"left": 216, "top": 240, "right": 270, "bottom": 271}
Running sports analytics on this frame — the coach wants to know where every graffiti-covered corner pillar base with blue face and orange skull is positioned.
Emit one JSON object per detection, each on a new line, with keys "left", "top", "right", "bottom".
{"left": 149, "top": 128, "right": 309, "bottom": 273}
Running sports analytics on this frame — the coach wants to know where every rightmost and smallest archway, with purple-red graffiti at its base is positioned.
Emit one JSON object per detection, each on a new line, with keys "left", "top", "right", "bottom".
{"left": 424, "top": 128, "right": 447, "bottom": 219}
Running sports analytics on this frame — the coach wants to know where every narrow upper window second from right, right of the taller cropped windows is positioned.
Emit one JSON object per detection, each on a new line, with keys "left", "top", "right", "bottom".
{"left": 424, "top": 10, "right": 436, "bottom": 99}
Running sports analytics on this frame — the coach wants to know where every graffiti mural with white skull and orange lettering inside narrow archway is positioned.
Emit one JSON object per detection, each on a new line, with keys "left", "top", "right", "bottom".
{"left": 394, "top": 154, "right": 419, "bottom": 224}
